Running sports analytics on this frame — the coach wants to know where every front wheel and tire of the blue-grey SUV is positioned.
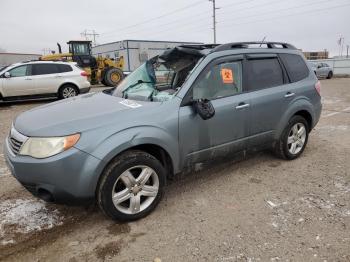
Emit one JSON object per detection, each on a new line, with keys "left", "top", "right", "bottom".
{"left": 97, "top": 150, "right": 166, "bottom": 222}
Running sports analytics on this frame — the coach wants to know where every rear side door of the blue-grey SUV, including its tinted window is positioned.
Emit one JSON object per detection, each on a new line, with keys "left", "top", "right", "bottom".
{"left": 244, "top": 54, "right": 288, "bottom": 146}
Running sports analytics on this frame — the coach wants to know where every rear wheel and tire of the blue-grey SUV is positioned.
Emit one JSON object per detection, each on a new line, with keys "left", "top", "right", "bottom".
{"left": 275, "top": 115, "right": 309, "bottom": 160}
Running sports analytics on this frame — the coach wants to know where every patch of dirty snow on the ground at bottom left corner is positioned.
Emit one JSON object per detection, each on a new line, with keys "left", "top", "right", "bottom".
{"left": 0, "top": 199, "right": 63, "bottom": 245}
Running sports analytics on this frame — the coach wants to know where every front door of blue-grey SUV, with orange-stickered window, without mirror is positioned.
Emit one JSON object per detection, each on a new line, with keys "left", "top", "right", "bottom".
{"left": 179, "top": 57, "right": 250, "bottom": 165}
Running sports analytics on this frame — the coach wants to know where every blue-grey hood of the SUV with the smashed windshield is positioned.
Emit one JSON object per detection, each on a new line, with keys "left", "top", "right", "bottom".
{"left": 14, "top": 92, "right": 161, "bottom": 137}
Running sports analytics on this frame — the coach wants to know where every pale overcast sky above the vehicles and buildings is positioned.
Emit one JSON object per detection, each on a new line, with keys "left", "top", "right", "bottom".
{"left": 0, "top": 0, "right": 350, "bottom": 55}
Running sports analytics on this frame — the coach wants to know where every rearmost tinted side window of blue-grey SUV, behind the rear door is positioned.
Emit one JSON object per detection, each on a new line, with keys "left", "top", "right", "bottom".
{"left": 280, "top": 54, "right": 309, "bottom": 83}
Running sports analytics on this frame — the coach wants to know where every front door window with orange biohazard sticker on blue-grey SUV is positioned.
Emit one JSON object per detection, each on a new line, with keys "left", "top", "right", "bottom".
{"left": 193, "top": 62, "right": 242, "bottom": 100}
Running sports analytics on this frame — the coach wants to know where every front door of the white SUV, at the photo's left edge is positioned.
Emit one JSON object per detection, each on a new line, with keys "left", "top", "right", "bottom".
{"left": 2, "top": 65, "right": 35, "bottom": 97}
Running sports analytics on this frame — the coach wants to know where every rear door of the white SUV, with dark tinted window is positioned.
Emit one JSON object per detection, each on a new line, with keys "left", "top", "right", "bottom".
{"left": 33, "top": 63, "right": 62, "bottom": 94}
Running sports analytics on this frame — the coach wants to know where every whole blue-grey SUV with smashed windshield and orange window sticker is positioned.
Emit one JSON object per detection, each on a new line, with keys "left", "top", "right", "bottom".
{"left": 5, "top": 42, "right": 322, "bottom": 221}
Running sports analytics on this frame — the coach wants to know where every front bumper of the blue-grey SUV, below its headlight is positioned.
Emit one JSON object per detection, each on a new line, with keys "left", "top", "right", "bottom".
{"left": 4, "top": 139, "right": 102, "bottom": 204}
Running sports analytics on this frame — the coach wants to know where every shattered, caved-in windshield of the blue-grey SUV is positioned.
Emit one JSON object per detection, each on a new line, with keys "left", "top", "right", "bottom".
{"left": 113, "top": 45, "right": 203, "bottom": 102}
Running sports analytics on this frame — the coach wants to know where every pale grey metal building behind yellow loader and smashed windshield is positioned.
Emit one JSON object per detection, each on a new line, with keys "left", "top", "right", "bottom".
{"left": 92, "top": 40, "right": 201, "bottom": 71}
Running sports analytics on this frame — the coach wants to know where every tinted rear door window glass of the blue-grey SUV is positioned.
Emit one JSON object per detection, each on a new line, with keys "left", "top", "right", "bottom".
{"left": 247, "top": 58, "right": 283, "bottom": 90}
